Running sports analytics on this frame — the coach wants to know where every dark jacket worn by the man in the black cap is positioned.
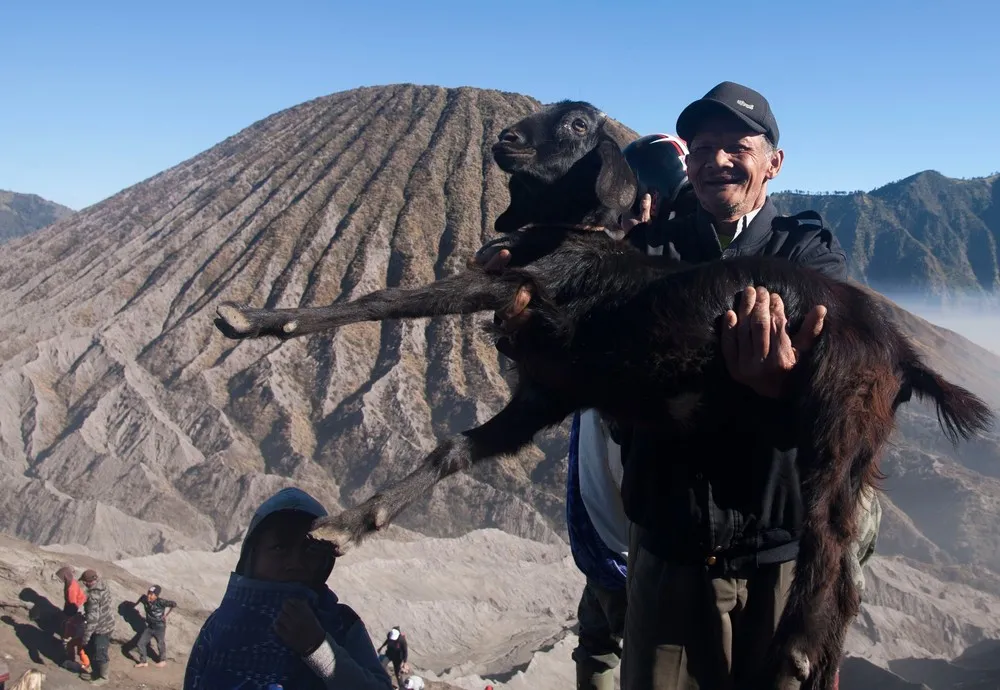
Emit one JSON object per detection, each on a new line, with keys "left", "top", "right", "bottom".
{"left": 622, "top": 199, "right": 847, "bottom": 576}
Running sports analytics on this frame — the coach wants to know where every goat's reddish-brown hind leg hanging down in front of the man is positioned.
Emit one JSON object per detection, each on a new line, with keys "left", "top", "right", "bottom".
{"left": 753, "top": 368, "right": 898, "bottom": 690}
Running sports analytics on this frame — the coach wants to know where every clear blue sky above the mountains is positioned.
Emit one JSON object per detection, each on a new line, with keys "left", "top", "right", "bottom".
{"left": 0, "top": 0, "right": 1000, "bottom": 208}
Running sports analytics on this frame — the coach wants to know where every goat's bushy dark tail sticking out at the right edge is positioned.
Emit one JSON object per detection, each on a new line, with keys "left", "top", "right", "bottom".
{"left": 903, "top": 358, "right": 995, "bottom": 445}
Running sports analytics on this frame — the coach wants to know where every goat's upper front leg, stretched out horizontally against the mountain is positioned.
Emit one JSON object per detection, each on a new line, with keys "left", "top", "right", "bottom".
{"left": 215, "top": 268, "right": 518, "bottom": 340}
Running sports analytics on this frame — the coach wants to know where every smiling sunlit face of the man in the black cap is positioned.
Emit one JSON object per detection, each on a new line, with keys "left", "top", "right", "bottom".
{"left": 687, "top": 114, "right": 784, "bottom": 222}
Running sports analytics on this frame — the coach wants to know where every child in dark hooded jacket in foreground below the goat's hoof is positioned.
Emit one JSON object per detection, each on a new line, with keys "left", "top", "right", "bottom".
{"left": 184, "top": 488, "right": 392, "bottom": 690}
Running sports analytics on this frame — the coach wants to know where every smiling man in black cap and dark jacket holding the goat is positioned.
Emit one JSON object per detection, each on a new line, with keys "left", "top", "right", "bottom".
{"left": 492, "top": 82, "right": 880, "bottom": 690}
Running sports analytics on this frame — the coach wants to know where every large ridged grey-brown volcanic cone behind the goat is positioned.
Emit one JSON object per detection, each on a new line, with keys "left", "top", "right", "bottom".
{"left": 0, "top": 85, "right": 1000, "bottom": 596}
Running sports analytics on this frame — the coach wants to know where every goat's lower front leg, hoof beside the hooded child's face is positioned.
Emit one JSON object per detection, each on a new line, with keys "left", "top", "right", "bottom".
{"left": 312, "top": 386, "right": 575, "bottom": 556}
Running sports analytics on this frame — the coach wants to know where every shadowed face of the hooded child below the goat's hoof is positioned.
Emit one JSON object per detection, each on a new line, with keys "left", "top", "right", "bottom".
{"left": 251, "top": 515, "right": 333, "bottom": 585}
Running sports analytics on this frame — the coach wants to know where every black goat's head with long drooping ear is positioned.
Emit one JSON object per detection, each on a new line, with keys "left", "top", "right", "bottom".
{"left": 493, "top": 101, "right": 637, "bottom": 232}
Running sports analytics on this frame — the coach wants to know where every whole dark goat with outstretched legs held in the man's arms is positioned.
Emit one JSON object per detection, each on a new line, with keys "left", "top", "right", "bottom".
{"left": 216, "top": 103, "right": 992, "bottom": 690}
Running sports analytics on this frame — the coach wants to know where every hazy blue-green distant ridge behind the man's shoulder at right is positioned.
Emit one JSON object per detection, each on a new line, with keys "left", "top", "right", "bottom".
{"left": 773, "top": 171, "right": 1000, "bottom": 296}
